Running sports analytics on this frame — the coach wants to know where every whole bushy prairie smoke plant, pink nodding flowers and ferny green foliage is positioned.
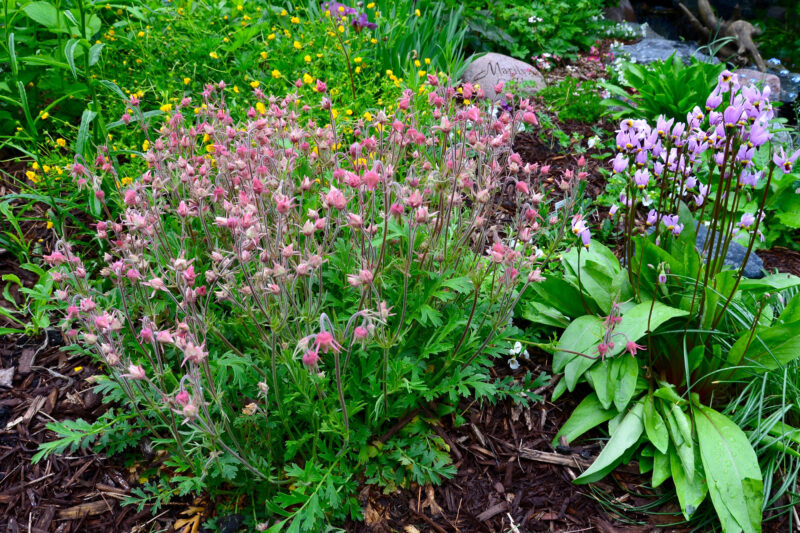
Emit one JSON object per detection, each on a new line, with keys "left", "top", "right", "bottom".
{"left": 46, "top": 79, "right": 572, "bottom": 529}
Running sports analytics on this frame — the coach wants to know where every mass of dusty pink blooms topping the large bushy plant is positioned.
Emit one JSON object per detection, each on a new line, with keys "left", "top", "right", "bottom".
{"left": 46, "top": 74, "right": 576, "bottom": 428}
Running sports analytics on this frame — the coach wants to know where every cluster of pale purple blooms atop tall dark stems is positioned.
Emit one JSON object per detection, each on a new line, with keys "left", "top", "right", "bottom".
{"left": 611, "top": 70, "right": 800, "bottom": 241}
